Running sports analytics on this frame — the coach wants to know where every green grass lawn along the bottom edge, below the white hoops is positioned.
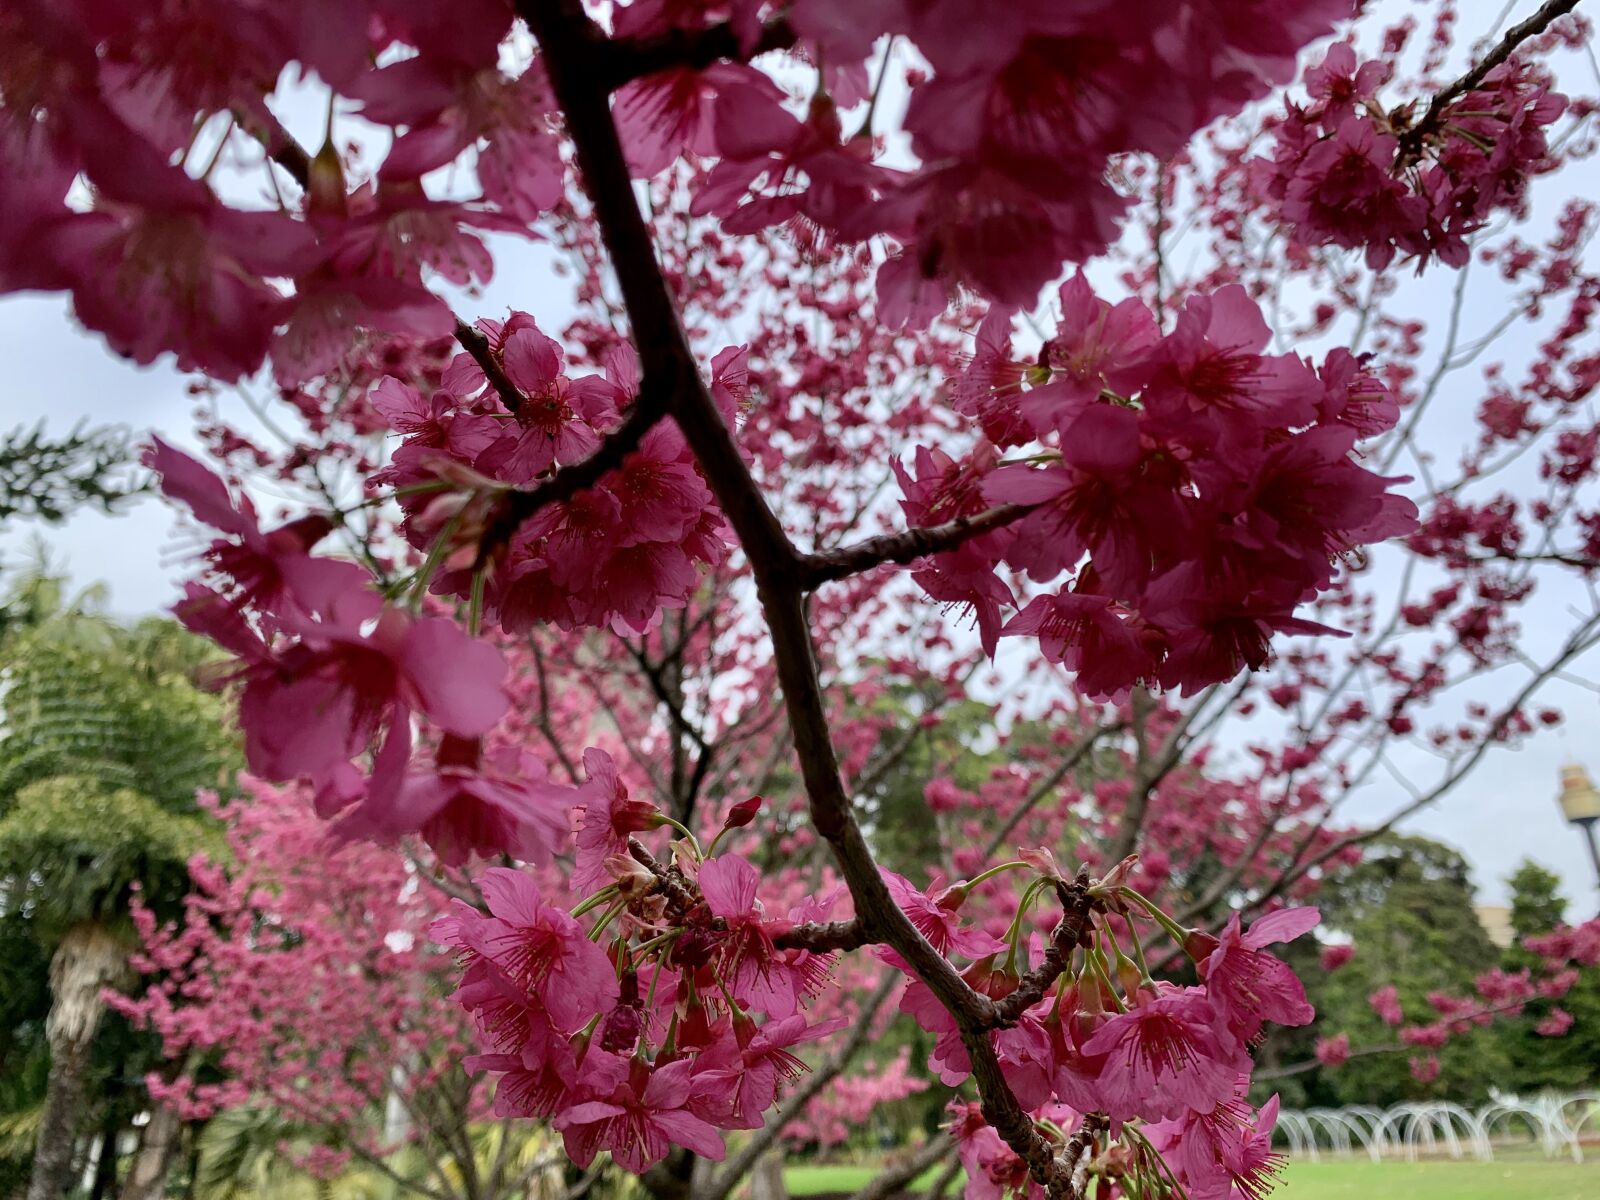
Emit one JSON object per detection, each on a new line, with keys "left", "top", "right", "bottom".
{"left": 784, "top": 1160, "right": 1600, "bottom": 1200}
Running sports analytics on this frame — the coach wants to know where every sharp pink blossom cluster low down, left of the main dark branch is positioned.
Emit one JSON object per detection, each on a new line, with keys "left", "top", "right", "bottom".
{"left": 434, "top": 790, "right": 843, "bottom": 1173}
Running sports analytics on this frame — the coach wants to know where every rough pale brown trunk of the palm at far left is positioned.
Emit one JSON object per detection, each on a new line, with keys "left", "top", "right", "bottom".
{"left": 27, "top": 923, "right": 128, "bottom": 1200}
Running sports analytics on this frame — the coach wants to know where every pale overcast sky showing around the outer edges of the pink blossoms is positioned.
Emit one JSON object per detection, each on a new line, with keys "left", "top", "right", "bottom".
{"left": 9, "top": 5, "right": 1600, "bottom": 918}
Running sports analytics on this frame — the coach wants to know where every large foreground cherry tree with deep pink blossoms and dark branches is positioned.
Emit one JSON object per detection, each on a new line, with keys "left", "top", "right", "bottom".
{"left": 12, "top": 0, "right": 1600, "bottom": 1200}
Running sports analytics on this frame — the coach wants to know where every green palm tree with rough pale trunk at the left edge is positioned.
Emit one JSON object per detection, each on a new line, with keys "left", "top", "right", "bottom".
{"left": 0, "top": 574, "right": 234, "bottom": 1200}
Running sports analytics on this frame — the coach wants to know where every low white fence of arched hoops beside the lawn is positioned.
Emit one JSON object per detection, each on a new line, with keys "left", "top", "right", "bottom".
{"left": 1278, "top": 1091, "right": 1600, "bottom": 1163}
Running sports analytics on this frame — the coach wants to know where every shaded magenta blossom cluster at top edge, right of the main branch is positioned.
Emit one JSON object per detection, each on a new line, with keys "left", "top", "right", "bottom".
{"left": 618, "top": 0, "right": 1349, "bottom": 325}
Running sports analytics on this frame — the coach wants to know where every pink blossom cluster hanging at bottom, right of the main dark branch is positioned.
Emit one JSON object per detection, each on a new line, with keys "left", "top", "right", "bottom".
{"left": 921, "top": 854, "right": 1317, "bottom": 1200}
